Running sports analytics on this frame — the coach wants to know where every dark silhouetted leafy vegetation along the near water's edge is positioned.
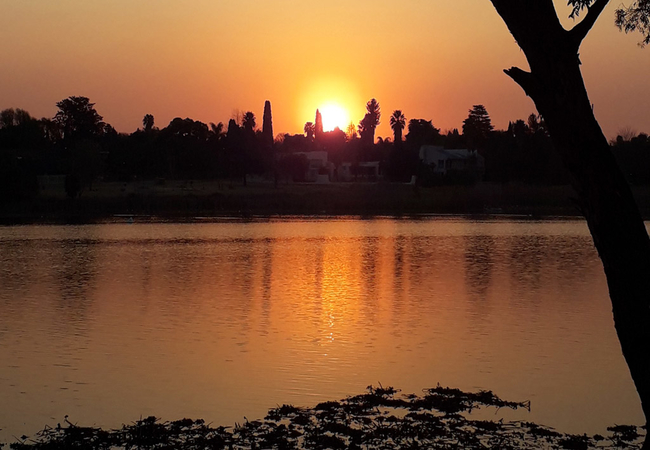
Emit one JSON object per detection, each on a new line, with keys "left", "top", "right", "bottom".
{"left": 5, "top": 385, "right": 643, "bottom": 450}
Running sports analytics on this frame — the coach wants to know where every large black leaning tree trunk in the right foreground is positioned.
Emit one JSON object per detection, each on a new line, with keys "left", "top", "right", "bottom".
{"left": 491, "top": 0, "right": 650, "bottom": 440}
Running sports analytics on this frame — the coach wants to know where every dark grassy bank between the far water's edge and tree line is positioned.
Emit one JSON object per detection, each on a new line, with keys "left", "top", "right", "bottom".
{"left": 0, "top": 181, "right": 588, "bottom": 223}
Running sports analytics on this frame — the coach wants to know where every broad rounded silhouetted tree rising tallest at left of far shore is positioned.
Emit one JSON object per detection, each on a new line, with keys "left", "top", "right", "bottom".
{"left": 54, "top": 97, "right": 104, "bottom": 140}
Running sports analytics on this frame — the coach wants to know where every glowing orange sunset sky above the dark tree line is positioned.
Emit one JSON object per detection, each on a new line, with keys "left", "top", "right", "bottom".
{"left": 0, "top": 0, "right": 650, "bottom": 137}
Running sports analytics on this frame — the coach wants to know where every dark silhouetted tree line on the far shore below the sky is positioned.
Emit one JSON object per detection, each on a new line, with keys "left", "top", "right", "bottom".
{"left": 0, "top": 97, "right": 650, "bottom": 199}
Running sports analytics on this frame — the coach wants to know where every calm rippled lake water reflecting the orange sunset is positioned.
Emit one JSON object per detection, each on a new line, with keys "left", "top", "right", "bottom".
{"left": 0, "top": 219, "right": 642, "bottom": 442}
